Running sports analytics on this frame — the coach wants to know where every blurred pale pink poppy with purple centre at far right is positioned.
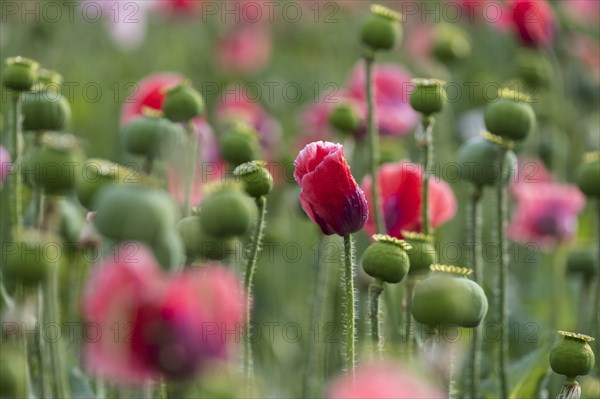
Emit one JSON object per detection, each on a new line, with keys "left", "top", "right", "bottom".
{"left": 507, "top": 181, "right": 585, "bottom": 248}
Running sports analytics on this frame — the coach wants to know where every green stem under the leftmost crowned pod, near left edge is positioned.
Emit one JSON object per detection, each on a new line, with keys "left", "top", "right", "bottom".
{"left": 8, "top": 92, "right": 23, "bottom": 241}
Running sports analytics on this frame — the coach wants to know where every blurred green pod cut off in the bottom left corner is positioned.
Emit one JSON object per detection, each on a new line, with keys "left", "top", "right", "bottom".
{"left": 0, "top": 344, "right": 28, "bottom": 398}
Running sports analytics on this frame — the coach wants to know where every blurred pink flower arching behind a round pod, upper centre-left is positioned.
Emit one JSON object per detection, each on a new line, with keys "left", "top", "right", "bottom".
{"left": 216, "top": 83, "right": 281, "bottom": 160}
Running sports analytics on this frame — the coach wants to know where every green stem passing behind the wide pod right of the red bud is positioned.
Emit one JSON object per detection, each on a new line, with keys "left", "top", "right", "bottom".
{"left": 469, "top": 187, "right": 483, "bottom": 399}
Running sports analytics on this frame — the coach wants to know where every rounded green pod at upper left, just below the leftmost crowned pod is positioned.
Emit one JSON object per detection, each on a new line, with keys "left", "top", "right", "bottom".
{"left": 22, "top": 90, "right": 71, "bottom": 131}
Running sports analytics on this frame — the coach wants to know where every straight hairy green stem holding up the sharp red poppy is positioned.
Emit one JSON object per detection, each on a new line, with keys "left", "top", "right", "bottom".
{"left": 344, "top": 235, "right": 356, "bottom": 378}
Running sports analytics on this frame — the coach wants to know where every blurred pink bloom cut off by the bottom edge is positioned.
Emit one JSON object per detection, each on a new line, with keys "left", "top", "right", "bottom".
{"left": 326, "top": 361, "right": 446, "bottom": 399}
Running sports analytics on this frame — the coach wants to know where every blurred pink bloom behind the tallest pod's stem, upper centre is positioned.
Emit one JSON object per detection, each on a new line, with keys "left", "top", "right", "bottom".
{"left": 346, "top": 62, "right": 419, "bottom": 136}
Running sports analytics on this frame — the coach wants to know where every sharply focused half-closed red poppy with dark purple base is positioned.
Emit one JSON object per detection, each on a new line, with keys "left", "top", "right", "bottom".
{"left": 294, "top": 141, "right": 368, "bottom": 236}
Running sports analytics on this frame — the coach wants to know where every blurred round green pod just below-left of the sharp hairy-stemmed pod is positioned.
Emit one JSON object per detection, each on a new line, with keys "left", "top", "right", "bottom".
{"left": 200, "top": 186, "right": 254, "bottom": 238}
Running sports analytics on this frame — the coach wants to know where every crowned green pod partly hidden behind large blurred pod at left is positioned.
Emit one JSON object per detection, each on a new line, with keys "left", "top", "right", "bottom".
{"left": 75, "top": 158, "right": 139, "bottom": 210}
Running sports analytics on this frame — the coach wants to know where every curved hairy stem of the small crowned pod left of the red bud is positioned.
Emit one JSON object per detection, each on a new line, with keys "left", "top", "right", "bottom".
{"left": 244, "top": 196, "right": 267, "bottom": 388}
